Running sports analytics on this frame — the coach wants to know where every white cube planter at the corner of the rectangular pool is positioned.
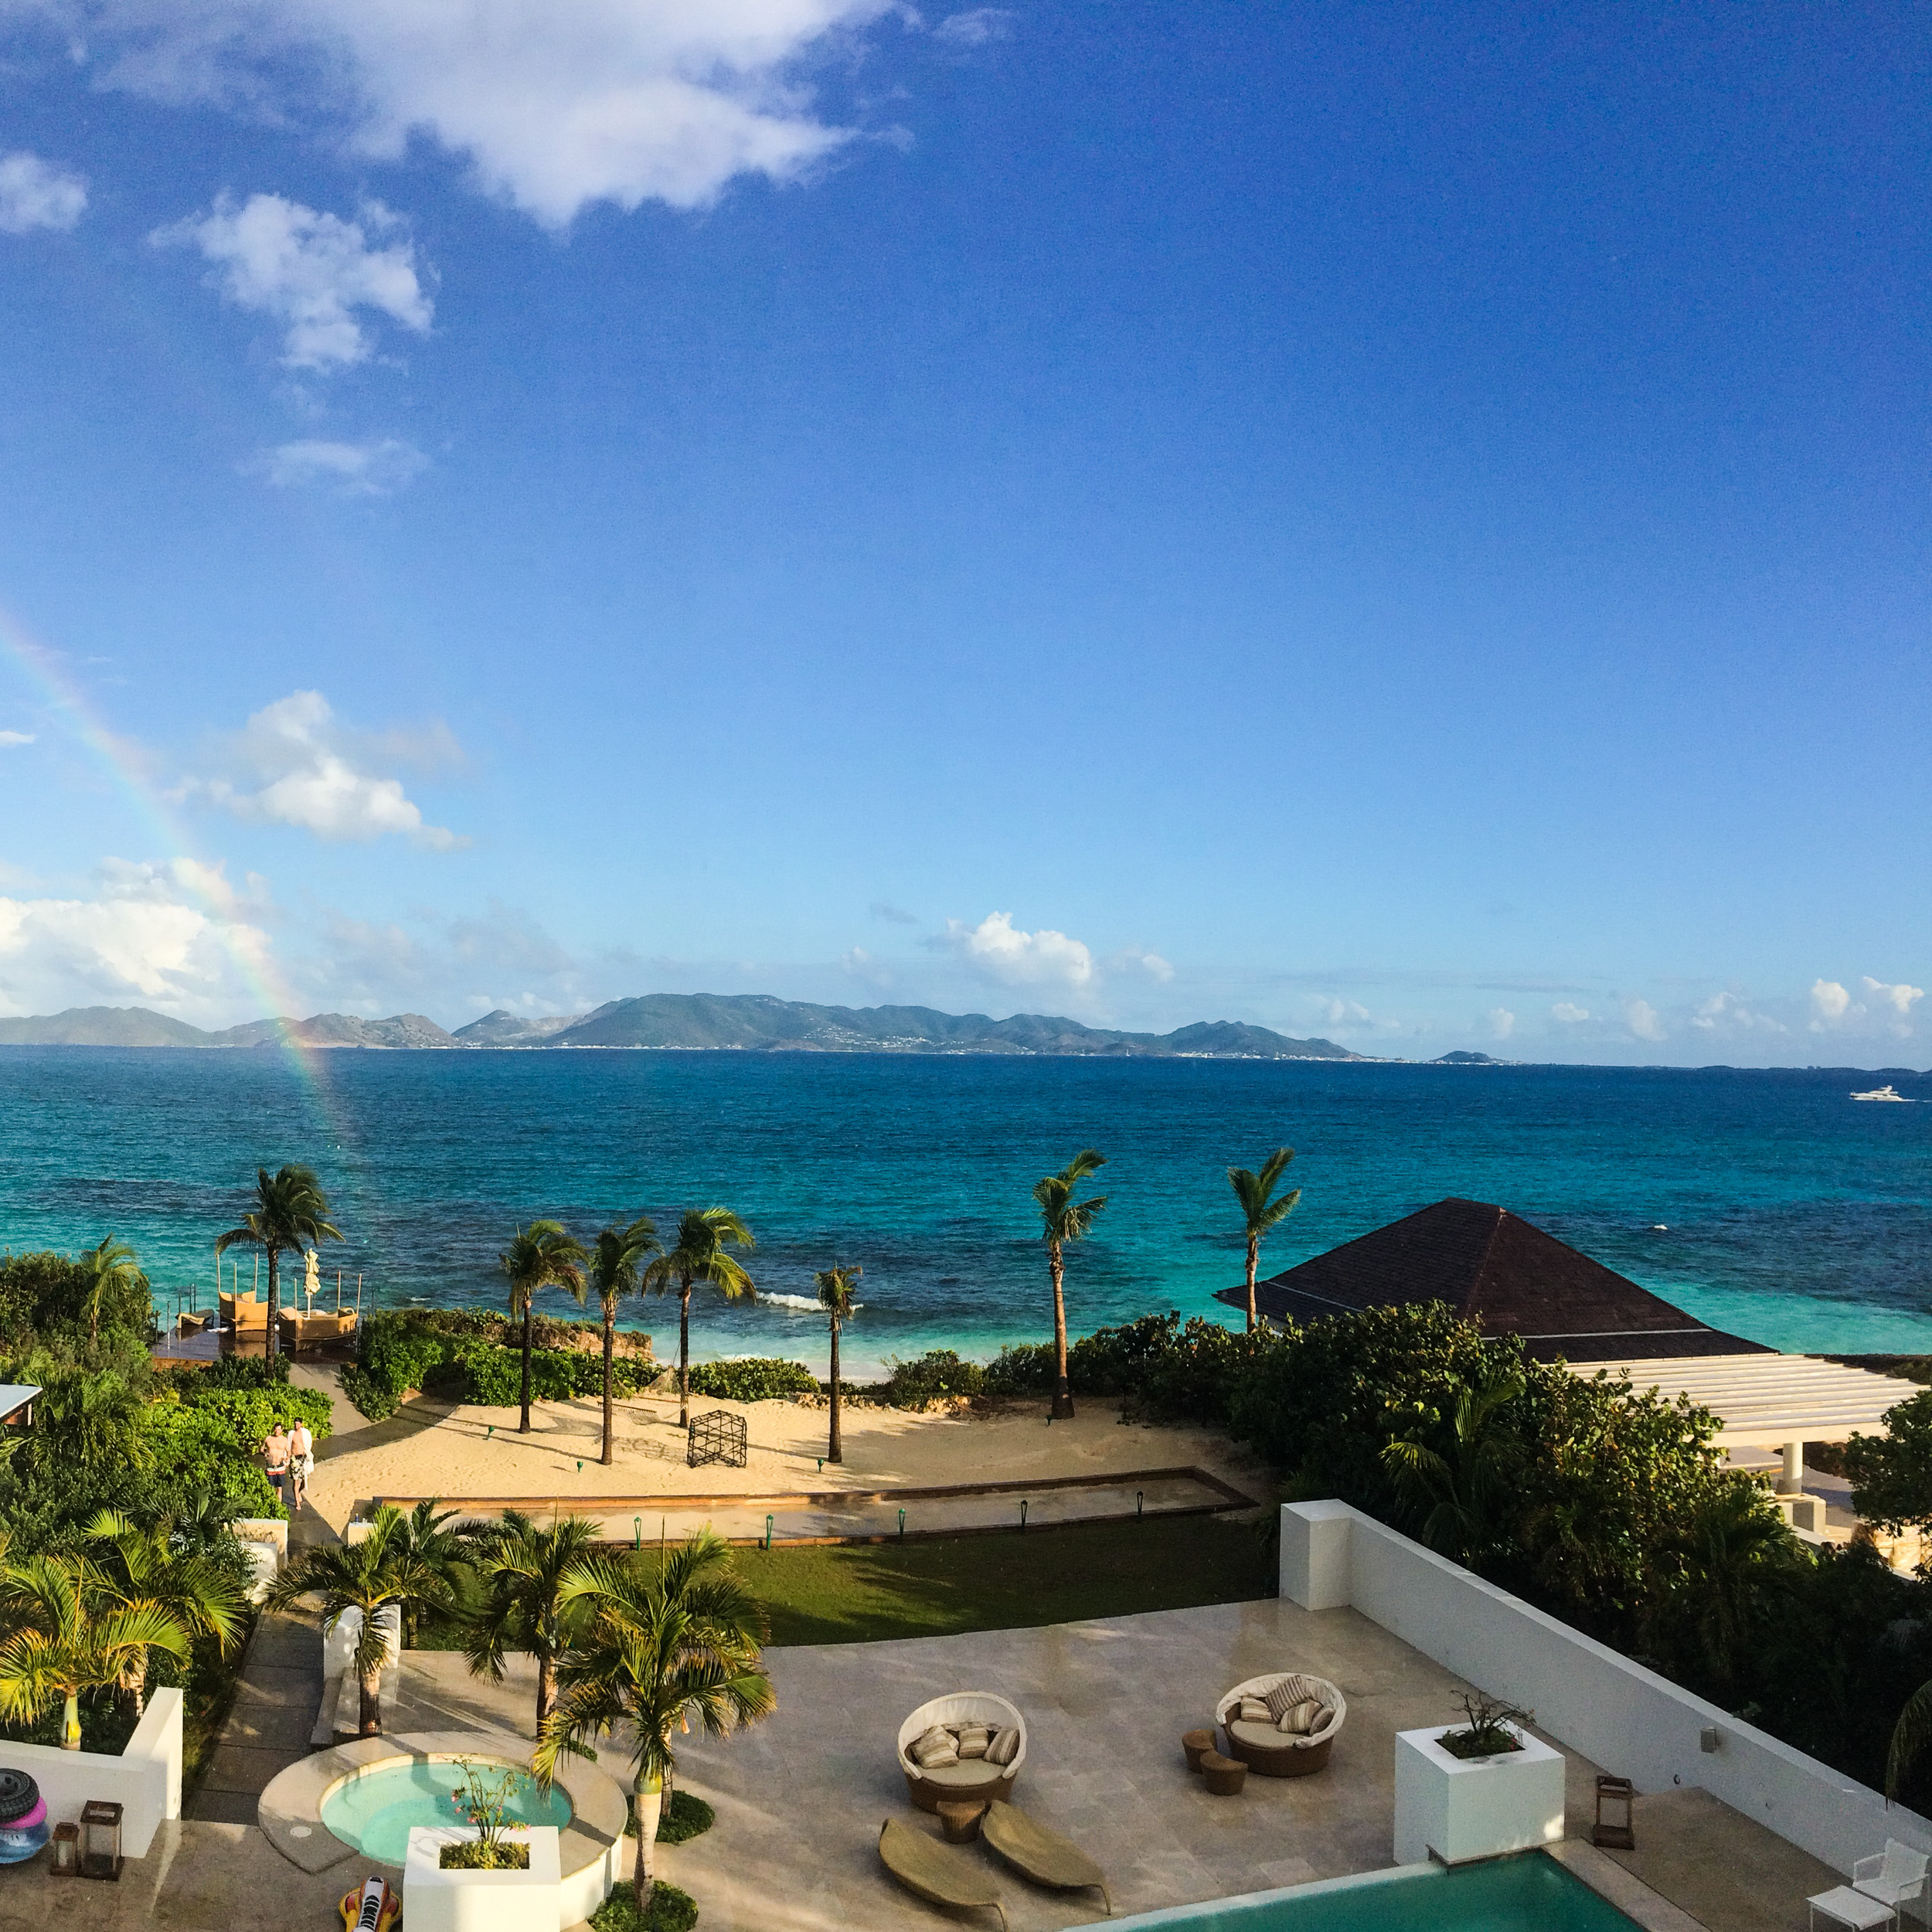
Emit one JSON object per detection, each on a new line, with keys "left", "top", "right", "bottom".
{"left": 1399, "top": 1723, "right": 1563, "bottom": 1862}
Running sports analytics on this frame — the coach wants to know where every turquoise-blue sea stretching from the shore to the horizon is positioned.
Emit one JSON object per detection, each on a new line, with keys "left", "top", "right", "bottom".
{"left": 0, "top": 1047, "right": 1932, "bottom": 1370}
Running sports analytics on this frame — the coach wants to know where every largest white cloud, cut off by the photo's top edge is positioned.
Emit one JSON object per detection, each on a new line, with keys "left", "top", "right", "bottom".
{"left": 60, "top": 0, "right": 899, "bottom": 226}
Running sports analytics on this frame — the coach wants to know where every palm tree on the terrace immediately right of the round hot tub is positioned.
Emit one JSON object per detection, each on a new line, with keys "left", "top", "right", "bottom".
{"left": 529, "top": 1529, "right": 779, "bottom": 1907}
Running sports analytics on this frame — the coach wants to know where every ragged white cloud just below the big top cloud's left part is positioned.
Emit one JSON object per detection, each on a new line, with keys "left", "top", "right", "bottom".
{"left": 149, "top": 193, "right": 433, "bottom": 369}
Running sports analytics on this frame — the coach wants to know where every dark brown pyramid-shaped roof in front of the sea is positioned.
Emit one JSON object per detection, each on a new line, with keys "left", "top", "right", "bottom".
{"left": 1217, "top": 1198, "right": 1770, "bottom": 1362}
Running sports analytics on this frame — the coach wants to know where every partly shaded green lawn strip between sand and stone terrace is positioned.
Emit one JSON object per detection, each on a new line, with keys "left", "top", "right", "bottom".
{"left": 736, "top": 1517, "right": 1274, "bottom": 1645}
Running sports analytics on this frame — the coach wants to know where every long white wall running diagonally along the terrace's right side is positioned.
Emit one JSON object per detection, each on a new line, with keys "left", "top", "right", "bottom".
{"left": 1281, "top": 1503, "right": 1932, "bottom": 1874}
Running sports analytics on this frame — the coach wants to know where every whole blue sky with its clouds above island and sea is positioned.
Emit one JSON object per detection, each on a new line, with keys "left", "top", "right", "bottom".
{"left": 0, "top": 0, "right": 1932, "bottom": 1065}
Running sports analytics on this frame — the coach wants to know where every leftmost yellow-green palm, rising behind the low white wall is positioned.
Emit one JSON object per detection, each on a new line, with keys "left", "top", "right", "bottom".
{"left": 0, "top": 1540, "right": 192, "bottom": 1750}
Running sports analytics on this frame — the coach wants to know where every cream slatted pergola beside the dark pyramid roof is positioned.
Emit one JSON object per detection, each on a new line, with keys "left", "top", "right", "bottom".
{"left": 1569, "top": 1355, "right": 1917, "bottom": 1495}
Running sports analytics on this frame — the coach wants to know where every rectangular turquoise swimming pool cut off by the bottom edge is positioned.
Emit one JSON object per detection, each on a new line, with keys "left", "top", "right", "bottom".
{"left": 1115, "top": 1851, "right": 1637, "bottom": 1932}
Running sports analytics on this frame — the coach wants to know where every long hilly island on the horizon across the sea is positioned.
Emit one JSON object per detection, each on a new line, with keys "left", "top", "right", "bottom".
{"left": 0, "top": 993, "right": 1372, "bottom": 1061}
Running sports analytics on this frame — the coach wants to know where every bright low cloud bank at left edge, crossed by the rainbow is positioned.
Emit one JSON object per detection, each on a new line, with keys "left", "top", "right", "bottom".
{"left": 0, "top": 860, "right": 269, "bottom": 1012}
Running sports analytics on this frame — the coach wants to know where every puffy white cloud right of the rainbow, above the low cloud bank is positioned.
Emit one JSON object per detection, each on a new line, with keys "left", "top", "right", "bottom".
{"left": 178, "top": 692, "right": 468, "bottom": 852}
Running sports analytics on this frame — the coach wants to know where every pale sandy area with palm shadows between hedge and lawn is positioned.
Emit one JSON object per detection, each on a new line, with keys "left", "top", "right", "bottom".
{"left": 309, "top": 1397, "right": 1271, "bottom": 1538}
